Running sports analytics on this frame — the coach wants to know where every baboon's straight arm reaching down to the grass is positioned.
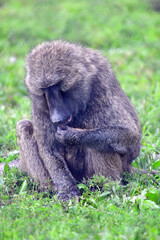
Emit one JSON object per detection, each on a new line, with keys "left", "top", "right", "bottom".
{"left": 32, "top": 102, "right": 79, "bottom": 199}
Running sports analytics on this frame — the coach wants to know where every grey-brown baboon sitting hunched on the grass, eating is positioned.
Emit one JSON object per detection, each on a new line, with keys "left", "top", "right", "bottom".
{"left": 17, "top": 40, "right": 141, "bottom": 200}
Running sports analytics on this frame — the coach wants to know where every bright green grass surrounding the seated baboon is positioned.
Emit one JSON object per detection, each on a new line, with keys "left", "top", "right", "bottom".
{"left": 0, "top": 0, "right": 160, "bottom": 240}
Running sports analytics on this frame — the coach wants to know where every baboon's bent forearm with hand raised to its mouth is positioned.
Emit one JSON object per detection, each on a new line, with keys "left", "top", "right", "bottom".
{"left": 56, "top": 126, "right": 140, "bottom": 157}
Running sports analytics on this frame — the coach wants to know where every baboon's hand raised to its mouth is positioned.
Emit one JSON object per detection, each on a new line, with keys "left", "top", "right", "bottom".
{"left": 55, "top": 126, "right": 77, "bottom": 145}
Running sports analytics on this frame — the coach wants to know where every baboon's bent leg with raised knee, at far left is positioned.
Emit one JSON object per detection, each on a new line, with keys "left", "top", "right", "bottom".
{"left": 17, "top": 119, "right": 53, "bottom": 189}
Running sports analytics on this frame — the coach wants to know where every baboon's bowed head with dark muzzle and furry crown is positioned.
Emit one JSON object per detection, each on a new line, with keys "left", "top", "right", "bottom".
{"left": 25, "top": 41, "right": 96, "bottom": 124}
